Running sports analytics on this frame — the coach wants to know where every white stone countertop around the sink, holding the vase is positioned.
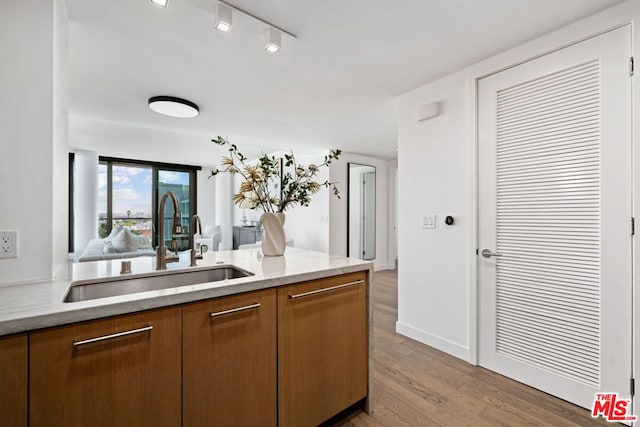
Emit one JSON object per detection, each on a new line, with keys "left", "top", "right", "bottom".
{"left": 0, "top": 247, "right": 373, "bottom": 335}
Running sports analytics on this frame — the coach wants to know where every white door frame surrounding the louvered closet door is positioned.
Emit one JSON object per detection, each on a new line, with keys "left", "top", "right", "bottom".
{"left": 466, "top": 9, "right": 640, "bottom": 368}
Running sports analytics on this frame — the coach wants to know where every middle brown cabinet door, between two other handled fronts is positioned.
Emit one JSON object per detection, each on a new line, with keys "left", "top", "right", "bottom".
{"left": 183, "top": 289, "right": 277, "bottom": 427}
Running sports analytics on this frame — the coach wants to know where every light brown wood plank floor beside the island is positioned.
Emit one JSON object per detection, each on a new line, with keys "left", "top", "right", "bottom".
{"left": 328, "top": 271, "right": 612, "bottom": 427}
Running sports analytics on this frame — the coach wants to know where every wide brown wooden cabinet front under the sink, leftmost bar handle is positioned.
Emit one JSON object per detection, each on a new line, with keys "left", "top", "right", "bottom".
{"left": 29, "top": 308, "right": 181, "bottom": 427}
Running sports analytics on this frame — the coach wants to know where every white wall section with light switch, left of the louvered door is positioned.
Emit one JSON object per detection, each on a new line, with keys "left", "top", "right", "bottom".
{"left": 397, "top": 74, "right": 471, "bottom": 358}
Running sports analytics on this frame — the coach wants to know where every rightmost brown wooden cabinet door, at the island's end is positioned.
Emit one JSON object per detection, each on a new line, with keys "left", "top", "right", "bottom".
{"left": 278, "top": 272, "right": 368, "bottom": 427}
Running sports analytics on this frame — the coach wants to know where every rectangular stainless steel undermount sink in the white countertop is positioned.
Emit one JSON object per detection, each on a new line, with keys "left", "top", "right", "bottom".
{"left": 62, "top": 266, "right": 253, "bottom": 302}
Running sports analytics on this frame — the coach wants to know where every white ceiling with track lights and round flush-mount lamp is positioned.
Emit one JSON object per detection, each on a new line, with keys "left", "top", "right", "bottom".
{"left": 67, "top": 0, "right": 620, "bottom": 165}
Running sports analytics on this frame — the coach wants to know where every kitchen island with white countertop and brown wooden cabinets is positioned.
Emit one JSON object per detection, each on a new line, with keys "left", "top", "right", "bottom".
{"left": 0, "top": 248, "right": 372, "bottom": 426}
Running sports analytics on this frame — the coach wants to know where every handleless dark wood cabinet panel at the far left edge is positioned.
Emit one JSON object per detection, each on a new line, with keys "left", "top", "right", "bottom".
{"left": 0, "top": 334, "right": 27, "bottom": 427}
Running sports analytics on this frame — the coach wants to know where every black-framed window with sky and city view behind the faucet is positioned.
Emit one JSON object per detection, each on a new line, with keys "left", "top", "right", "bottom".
{"left": 98, "top": 157, "right": 200, "bottom": 250}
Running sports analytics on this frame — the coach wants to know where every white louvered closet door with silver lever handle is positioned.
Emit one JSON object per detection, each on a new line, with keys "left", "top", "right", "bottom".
{"left": 478, "top": 27, "right": 632, "bottom": 408}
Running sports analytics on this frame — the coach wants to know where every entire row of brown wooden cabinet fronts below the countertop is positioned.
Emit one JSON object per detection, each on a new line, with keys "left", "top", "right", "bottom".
{"left": 20, "top": 272, "right": 368, "bottom": 427}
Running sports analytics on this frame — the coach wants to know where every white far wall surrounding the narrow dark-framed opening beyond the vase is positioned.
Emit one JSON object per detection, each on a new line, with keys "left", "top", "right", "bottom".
{"left": 329, "top": 153, "right": 394, "bottom": 270}
